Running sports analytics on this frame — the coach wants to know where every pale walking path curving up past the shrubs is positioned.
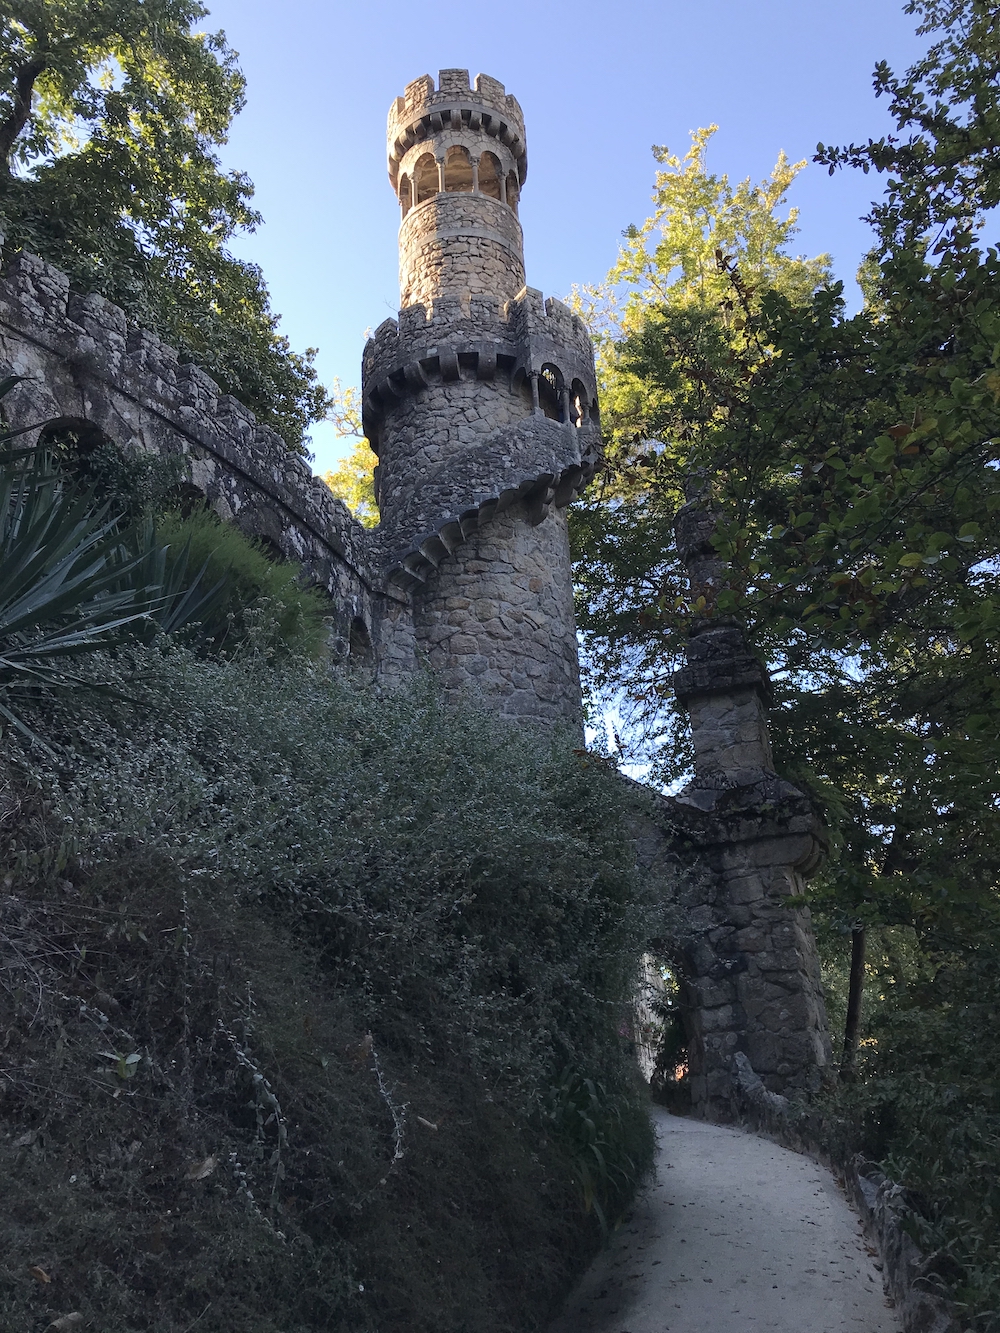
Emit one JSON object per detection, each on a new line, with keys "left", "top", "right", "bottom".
{"left": 549, "top": 1110, "right": 900, "bottom": 1333}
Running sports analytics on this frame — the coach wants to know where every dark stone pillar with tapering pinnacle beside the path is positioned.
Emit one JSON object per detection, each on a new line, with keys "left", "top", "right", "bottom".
{"left": 667, "top": 504, "right": 831, "bottom": 1120}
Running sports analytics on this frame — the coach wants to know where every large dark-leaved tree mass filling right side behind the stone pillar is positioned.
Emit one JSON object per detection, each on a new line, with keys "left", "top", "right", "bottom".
{"left": 580, "top": 0, "right": 1000, "bottom": 1082}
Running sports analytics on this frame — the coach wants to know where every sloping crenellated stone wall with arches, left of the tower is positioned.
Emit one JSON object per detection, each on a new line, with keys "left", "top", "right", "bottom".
{"left": 0, "top": 235, "right": 375, "bottom": 613}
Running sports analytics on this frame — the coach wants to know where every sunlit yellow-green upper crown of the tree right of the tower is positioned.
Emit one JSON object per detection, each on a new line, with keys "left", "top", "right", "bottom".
{"left": 575, "top": 125, "right": 829, "bottom": 469}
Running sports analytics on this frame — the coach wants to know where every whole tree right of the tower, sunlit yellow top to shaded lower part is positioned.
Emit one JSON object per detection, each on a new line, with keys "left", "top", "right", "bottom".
{"left": 571, "top": 125, "right": 829, "bottom": 757}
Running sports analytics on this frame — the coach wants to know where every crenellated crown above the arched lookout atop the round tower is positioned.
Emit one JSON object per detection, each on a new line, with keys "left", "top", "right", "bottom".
{"left": 387, "top": 69, "right": 527, "bottom": 189}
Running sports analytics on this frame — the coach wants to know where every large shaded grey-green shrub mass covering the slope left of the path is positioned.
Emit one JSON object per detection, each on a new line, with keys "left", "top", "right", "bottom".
{"left": 0, "top": 647, "right": 674, "bottom": 1333}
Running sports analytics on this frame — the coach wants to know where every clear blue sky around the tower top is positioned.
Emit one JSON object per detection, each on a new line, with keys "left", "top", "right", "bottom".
{"left": 205, "top": 0, "right": 920, "bottom": 471}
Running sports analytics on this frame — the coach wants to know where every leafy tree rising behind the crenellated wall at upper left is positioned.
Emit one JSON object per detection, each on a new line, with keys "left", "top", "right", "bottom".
{"left": 0, "top": 0, "right": 333, "bottom": 451}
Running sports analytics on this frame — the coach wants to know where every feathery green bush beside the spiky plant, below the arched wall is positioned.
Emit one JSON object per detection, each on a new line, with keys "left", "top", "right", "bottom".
{"left": 156, "top": 508, "right": 329, "bottom": 659}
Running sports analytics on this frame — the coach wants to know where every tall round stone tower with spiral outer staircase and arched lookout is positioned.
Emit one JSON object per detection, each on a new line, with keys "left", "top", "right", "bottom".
{"left": 363, "top": 69, "right": 600, "bottom": 724}
